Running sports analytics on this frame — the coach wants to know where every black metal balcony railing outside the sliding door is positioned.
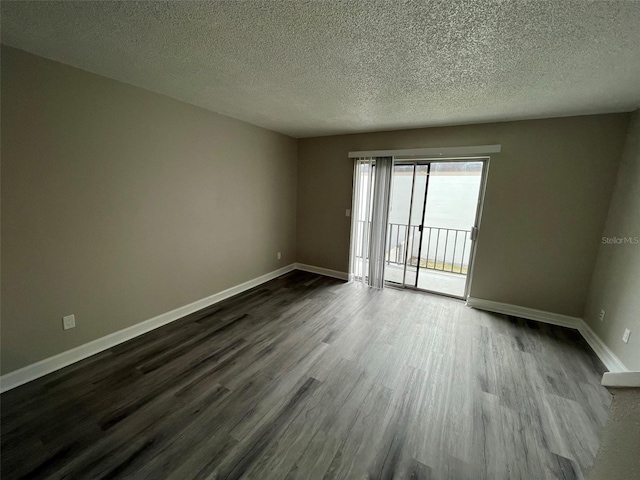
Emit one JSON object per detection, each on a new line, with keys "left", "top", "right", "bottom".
{"left": 356, "top": 221, "right": 471, "bottom": 275}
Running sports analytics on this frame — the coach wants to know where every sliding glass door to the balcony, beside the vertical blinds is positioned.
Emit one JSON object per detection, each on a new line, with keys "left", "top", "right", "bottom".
{"left": 385, "top": 161, "right": 484, "bottom": 297}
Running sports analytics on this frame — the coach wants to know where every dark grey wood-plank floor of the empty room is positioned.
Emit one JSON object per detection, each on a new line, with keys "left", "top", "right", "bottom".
{"left": 0, "top": 272, "right": 610, "bottom": 480}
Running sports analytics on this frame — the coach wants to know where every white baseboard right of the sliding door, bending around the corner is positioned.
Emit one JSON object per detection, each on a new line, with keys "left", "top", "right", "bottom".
{"left": 467, "top": 297, "right": 629, "bottom": 372}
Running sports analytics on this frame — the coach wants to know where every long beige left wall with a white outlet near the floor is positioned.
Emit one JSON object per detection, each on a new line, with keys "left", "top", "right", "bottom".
{"left": 2, "top": 47, "right": 296, "bottom": 373}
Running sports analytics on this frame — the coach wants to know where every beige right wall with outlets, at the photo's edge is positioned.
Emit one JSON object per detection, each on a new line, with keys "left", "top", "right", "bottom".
{"left": 584, "top": 110, "right": 640, "bottom": 370}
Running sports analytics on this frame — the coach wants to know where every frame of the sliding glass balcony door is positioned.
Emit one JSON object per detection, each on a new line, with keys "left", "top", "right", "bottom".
{"left": 385, "top": 156, "right": 491, "bottom": 300}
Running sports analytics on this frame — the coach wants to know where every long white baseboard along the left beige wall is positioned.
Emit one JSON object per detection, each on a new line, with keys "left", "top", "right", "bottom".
{"left": 0, "top": 264, "right": 296, "bottom": 393}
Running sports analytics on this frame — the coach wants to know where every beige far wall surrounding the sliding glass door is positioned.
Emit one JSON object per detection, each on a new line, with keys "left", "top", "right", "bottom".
{"left": 297, "top": 114, "right": 629, "bottom": 316}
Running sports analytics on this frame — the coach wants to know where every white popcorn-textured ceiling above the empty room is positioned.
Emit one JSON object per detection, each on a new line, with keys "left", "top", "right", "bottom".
{"left": 2, "top": 0, "right": 640, "bottom": 137}
